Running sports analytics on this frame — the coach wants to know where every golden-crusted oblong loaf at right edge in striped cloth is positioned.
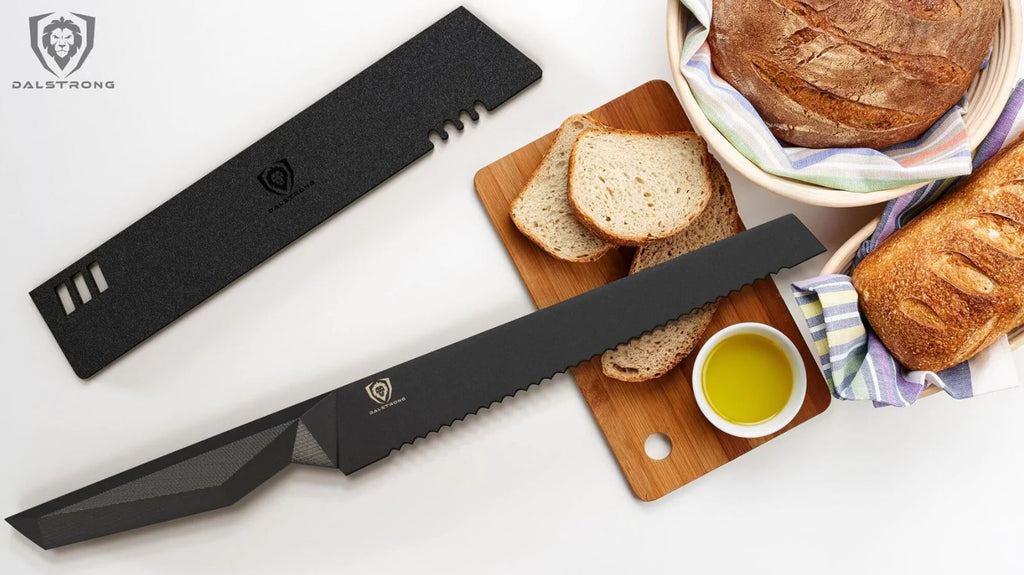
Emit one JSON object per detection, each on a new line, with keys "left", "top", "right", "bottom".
{"left": 853, "top": 131, "right": 1024, "bottom": 371}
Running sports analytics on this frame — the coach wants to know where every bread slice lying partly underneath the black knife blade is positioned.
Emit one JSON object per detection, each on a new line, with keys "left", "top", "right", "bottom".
{"left": 601, "top": 157, "right": 740, "bottom": 382}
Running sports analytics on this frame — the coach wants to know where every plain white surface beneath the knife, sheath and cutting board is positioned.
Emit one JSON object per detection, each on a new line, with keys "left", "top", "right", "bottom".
{"left": 0, "top": 0, "right": 1024, "bottom": 575}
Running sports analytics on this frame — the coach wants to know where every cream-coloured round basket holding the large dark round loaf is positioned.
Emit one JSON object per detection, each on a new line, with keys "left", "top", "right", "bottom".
{"left": 668, "top": 0, "right": 1022, "bottom": 208}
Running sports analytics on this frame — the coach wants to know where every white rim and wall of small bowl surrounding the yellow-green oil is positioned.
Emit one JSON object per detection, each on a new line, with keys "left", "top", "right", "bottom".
{"left": 690, "top": 322, "right": 807, "bottom": 438}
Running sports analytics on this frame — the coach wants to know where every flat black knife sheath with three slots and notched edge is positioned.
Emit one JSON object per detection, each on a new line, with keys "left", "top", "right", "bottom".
{"left": 31, "top": 8, "right": 541, "bottom": 379}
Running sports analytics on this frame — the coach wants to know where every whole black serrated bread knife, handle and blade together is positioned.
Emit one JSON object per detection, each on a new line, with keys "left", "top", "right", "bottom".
{"left": 7, "top": 215, "right": 824, "bottom": 548}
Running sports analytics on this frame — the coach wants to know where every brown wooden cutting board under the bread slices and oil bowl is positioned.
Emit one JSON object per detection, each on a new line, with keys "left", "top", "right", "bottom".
{"left": 474, "top": 81, "right": 830, "bottom": 501}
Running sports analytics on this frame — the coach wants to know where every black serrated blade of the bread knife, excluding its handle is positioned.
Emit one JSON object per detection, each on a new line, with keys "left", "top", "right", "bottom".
{"left": 336, "top": 215, "right": 824, "bottom": 474}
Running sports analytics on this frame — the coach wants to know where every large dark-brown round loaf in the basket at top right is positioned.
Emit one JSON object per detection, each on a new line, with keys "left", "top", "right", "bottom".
{"left": 708, "top": 0, "right": 1001, "bottom": 148}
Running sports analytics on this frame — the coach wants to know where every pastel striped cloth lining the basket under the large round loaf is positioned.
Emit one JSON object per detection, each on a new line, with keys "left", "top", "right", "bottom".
{"left": 680, "top": 0, "right": 971, "bottom": 191}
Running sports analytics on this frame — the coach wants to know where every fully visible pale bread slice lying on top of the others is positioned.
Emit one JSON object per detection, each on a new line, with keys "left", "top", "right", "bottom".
{"left": 568, "top": 129, "right": 711, "bottom": 246}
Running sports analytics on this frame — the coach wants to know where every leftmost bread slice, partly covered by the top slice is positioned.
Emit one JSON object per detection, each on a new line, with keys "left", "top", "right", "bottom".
{"left": 511, "top": 114, "right": 614, "bottom": 262}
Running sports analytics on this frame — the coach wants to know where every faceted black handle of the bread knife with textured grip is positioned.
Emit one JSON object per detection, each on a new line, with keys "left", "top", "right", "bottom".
{"left": 7, "top": 392, "right": 337, "bottom": 549}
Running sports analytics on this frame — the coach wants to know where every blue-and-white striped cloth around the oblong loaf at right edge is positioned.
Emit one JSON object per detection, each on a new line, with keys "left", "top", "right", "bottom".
{"left": 793, "top": 83, "right": 1024, "bottom": 406}
